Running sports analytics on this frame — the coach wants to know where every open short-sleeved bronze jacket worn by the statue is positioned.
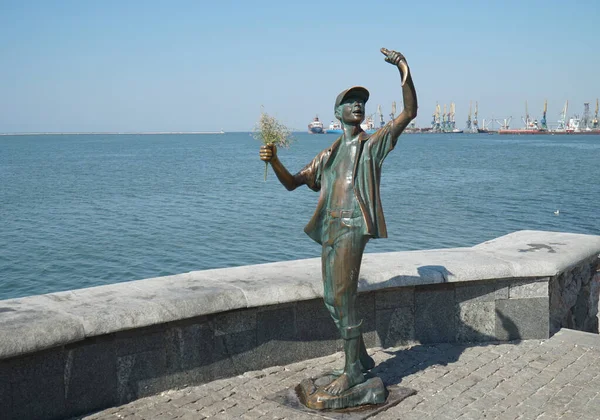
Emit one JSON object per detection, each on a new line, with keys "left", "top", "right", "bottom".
{"left": 296, "top": 121, "right": 396, "bottom": 244}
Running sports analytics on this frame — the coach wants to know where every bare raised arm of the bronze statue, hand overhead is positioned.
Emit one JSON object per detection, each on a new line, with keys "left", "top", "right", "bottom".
{"left": 381, "top": 48, "right": 418, "bottom": 139}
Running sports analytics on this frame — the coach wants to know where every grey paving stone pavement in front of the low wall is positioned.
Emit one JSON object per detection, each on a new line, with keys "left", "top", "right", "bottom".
{"left": 81, "top": 330, "right": 600, "bottom": 420}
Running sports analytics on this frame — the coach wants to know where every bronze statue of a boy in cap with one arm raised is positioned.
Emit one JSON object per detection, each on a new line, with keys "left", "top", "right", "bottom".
{"left": 260, "top": 48, "right": 417, "bottom": 406}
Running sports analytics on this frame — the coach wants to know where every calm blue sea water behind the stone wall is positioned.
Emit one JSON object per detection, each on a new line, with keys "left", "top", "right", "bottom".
{"left": 0, "top": 133, "right": 600, "bottom": 299}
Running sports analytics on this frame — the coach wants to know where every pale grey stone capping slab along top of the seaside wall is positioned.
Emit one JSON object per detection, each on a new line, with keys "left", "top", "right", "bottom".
{"left": 0, "top": 231, "right": 600, "bottom": 358}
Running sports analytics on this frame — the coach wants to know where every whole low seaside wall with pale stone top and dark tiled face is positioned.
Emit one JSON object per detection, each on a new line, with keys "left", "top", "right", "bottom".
{"left": 0, "top": 231, "right": 600, "bottom": 419}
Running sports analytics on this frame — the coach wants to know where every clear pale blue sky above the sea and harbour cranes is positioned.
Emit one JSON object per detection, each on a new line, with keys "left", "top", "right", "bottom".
{"left": 0, "top": 0, "right": 600, "bottom": 132}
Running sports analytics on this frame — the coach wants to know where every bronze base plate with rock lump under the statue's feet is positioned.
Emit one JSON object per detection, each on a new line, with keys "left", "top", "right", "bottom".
{"left": 268, "top": 375, "right": 416, "bottom": 420}
